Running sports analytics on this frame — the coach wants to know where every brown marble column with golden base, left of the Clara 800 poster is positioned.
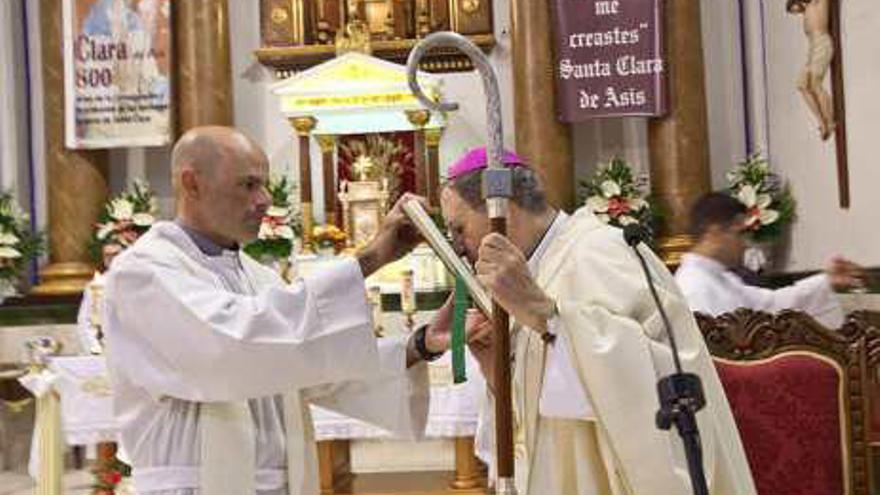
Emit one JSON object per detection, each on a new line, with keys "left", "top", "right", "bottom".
{"left": 33, "top": 0, "right": 108, "bottom": 295}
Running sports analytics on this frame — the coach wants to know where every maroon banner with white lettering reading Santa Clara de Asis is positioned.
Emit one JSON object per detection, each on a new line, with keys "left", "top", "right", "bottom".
{"left": 553, "top": 0, "right": 668, "bottom": 122}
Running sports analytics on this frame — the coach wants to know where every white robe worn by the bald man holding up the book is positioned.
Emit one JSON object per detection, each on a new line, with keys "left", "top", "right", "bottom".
{"left": 105, "top": 222, "right": 428, "bottom": 495}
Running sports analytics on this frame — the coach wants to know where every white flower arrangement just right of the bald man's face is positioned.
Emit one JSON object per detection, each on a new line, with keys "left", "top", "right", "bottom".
{"left": 244, "top": 176, "right": 302, "bottom": 262}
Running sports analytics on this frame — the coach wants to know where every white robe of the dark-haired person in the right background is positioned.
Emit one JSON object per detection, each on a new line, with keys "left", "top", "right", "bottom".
{"left": 675, "top": 253, "right": 844, "bottom": 329}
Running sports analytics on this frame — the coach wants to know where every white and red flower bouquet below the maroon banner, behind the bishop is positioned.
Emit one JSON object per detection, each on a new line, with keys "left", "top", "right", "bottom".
{"left": 580, "top": 158, "right": 656, "bottom": 238}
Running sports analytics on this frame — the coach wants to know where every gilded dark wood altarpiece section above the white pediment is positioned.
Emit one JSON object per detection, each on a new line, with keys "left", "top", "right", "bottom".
{"left": 255, "top": 0, "right": 495, "bottom": 77}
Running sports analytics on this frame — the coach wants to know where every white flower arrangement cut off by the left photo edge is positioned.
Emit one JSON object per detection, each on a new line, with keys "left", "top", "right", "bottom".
{"left": 0, "top": 192, "right": 44, "bottom": 300}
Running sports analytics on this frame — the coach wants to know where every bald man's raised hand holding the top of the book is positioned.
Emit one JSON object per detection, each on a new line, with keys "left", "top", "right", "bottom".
{"left": 357, "top": 193, "right": 428, "bottom": 277}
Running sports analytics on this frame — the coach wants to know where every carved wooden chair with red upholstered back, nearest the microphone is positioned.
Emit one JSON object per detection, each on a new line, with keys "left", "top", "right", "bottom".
{"left": 697, "top": 309, "right": 880, "bottom": 495}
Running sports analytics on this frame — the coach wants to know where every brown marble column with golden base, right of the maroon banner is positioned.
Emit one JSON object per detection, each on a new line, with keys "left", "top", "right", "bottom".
{"left": 648, "top": 2, "right": 712, "bottom": 266}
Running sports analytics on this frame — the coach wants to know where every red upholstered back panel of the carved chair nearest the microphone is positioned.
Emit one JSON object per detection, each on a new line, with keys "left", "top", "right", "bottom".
{"left": 716, "top": 352, "right": 846, "bottom": 495}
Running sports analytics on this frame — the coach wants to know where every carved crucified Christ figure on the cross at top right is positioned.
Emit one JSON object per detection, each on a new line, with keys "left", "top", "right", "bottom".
{"left": 786, "top": 0, "right": 835, "bottom": 141}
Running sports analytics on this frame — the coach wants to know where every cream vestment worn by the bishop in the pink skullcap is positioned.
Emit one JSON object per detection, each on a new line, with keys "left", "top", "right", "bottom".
{"left": 481, "top": 208, "right": 755, "bottom": 495}
